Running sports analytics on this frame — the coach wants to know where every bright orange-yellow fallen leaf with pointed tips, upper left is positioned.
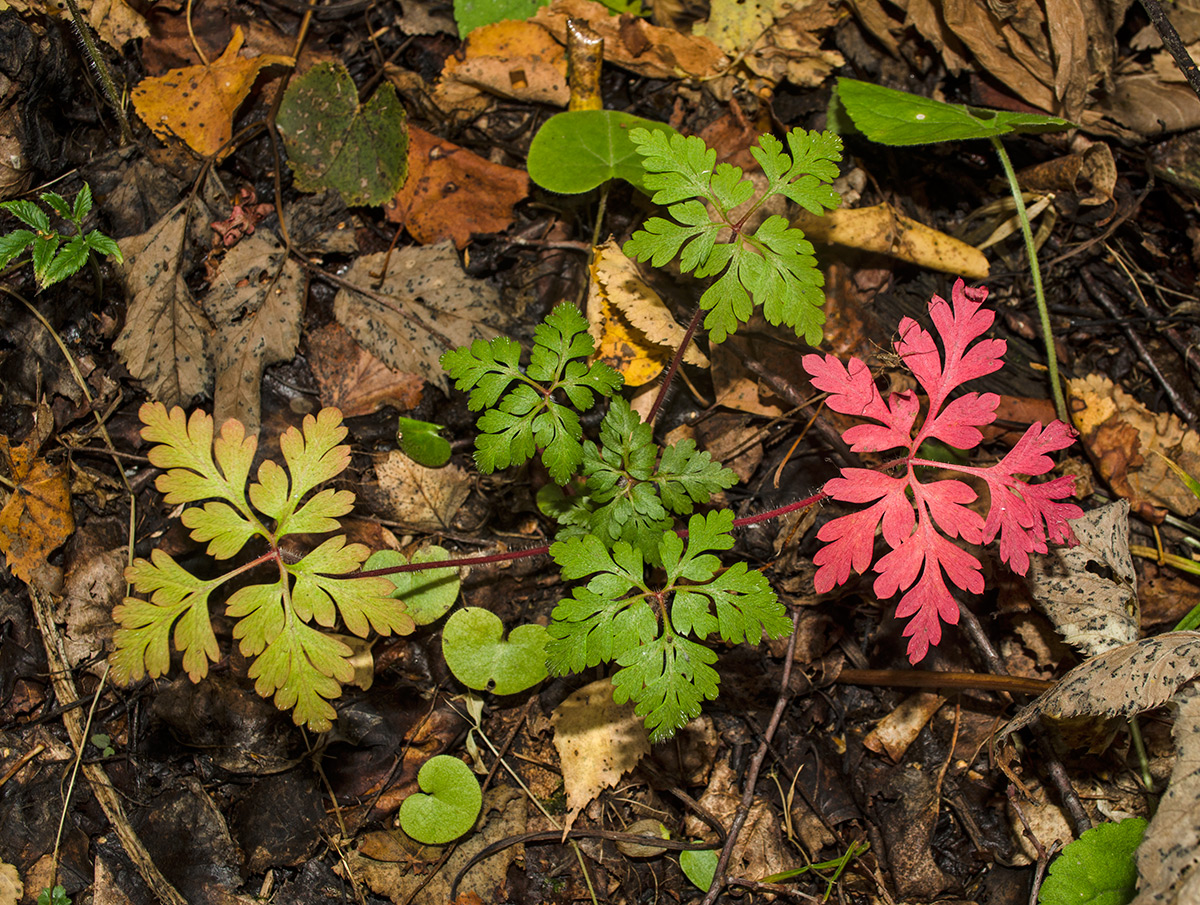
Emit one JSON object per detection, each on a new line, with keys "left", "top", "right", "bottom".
{"left": 132, "top": 26, "right": 294, "bottom": 160}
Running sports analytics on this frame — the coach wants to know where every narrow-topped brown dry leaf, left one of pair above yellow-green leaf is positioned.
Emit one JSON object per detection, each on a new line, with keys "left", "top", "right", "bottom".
{"left": 113, "top": 199, "right": 214, "bottom": 406}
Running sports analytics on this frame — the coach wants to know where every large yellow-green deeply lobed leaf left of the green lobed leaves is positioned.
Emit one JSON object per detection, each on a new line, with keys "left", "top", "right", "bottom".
{"left": 112, "top": 403, "right": 413, "bottom": 731}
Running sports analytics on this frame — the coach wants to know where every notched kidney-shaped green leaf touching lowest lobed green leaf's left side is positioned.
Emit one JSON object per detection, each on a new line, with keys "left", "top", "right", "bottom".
{"left": 442, "top": 606, "right": 548, "bottom": 695}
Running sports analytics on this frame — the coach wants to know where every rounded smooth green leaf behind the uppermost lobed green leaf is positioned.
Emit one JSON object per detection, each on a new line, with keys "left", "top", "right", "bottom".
{"left": 526, "top": 110, "right": 674, "bottom": 194}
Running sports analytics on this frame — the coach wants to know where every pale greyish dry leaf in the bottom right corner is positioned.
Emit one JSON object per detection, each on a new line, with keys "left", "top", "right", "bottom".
{"left": 1133, "top": 685, "right": 1200, "bottom": 905}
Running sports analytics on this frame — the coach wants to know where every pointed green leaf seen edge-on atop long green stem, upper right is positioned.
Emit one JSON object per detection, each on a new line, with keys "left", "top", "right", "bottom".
{"left": 835, "top": 78, "right": 1074, "bottom": 145}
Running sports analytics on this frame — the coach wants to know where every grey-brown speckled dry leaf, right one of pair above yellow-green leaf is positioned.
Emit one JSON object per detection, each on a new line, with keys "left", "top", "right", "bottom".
{"left": 203, "top": 229, "right": 306, "bottom": 436}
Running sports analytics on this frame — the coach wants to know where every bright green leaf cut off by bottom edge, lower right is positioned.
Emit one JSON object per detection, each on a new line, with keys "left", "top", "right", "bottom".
{"left": 1038, "top": 817, "right": 1146, "bottom": 905}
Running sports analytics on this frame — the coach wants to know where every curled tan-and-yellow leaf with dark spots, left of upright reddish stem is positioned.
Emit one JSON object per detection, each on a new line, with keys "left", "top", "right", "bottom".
{"left": 588, "top": 239, "right": 708, "bottom": 386}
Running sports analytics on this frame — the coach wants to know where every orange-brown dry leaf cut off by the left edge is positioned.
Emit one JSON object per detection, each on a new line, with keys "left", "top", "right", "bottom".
{"left": 0, "top": 404, "right": 74, "bottom": 582}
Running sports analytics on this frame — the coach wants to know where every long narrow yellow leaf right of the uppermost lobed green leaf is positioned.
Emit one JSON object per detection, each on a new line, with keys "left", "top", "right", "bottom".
{"left": 792, "top": 203, "right": 988, "bottom": 280}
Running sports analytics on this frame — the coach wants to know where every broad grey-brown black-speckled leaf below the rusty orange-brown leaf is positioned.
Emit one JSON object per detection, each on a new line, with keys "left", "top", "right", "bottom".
{"left": 334, "top": 241, "right": 508, "bottom": 391}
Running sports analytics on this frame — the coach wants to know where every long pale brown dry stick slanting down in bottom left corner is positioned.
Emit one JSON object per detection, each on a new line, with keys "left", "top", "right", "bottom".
{"left": 29, "top": 585, "right": 187, "bottom": 905}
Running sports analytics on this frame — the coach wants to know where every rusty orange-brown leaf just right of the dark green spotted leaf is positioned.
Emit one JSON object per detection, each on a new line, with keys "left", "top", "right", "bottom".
{"left": 384, "top": 126, "right": 529, "bottom": 250}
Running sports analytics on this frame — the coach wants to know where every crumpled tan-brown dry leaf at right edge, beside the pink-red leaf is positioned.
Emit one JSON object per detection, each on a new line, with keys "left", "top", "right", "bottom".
{"left": 1068, "top": 374, "right": 1200, "bottom": 522}
